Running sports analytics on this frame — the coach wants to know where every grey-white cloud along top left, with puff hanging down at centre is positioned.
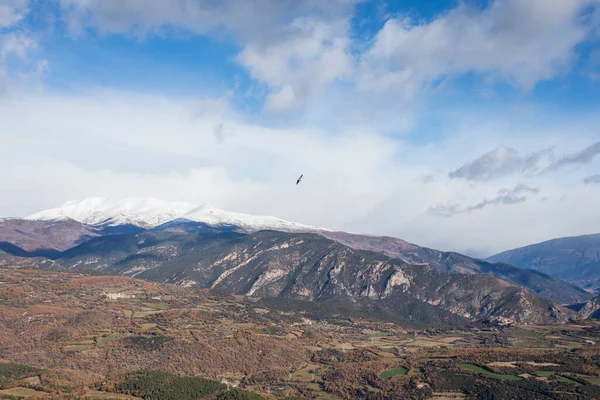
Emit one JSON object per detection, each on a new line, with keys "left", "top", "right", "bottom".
{"left": 52, "top": 0, "right": 357, "bottom": 111}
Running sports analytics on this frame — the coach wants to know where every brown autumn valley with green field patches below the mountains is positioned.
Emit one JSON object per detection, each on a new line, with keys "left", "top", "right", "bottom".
{"left": 0, "top": 268, "right": 600, "bottom": 399}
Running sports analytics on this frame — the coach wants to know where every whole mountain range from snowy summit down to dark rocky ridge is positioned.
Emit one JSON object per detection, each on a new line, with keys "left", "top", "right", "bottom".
{"left": 0, "top": 198, "right": 592, "bottom": 326}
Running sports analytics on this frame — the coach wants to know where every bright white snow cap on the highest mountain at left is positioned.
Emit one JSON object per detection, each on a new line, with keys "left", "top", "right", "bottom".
{"left": 25, "top": 197, "right": 327, "bottom": 231}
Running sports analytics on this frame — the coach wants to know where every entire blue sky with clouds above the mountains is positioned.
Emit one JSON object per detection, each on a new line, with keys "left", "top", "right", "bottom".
{"left": 0, "top": 0, "right": 600, "bottom": 257}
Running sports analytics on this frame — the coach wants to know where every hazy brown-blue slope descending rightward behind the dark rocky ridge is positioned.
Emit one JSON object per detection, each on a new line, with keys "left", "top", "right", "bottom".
{"left": 321, "top": 232, "right": 592, "bottom": 304}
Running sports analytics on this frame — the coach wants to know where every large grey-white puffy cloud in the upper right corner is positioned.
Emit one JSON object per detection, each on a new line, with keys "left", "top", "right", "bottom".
{"left": 358, "top": 0, "right": 595, "bottom": 94}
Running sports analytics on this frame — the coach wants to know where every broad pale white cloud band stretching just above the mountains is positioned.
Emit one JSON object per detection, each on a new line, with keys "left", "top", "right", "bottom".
{"left": 0, "top": 92, "right": 600, "bottom": 255}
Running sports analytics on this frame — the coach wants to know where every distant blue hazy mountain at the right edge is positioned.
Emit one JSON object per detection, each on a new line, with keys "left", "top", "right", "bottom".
{"left": 489, "top": 234, "right": 600, "bottom": 290}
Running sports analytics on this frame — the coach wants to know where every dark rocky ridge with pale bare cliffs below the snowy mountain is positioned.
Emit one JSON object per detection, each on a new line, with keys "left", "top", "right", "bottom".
{"left": 56, "top": 231, "right": 576, "bottom": 325}
